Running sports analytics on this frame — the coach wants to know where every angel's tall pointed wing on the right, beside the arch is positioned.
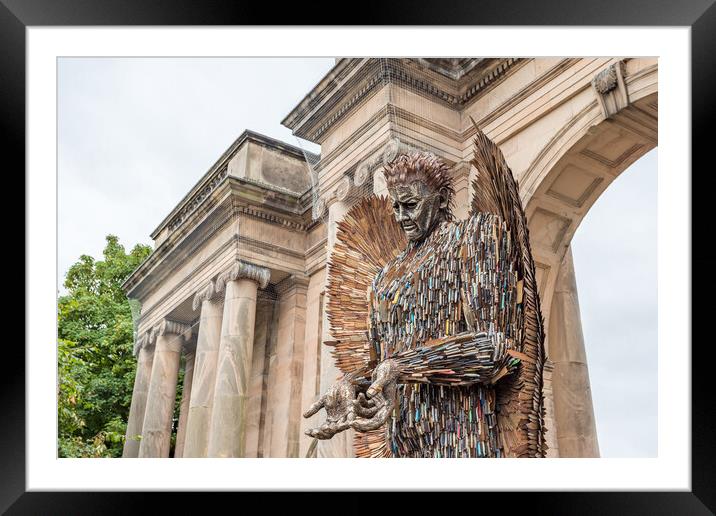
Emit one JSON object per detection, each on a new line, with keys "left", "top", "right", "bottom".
{"left": 471, "top": 118, "right": 547, "bottom": 457}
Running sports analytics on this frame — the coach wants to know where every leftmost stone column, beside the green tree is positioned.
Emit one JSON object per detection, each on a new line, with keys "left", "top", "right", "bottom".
{"left": 122, "top": 332, "right": 154, "bottom": 458}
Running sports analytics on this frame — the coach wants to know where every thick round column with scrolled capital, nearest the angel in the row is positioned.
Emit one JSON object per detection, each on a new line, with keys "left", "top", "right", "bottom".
{"left": 208, "top": 261, "right": 270, "bottom": 457}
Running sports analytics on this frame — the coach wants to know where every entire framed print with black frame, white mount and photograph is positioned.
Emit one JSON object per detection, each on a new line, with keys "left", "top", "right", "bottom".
{"left": 9, "top": 2, "right": 716, "bottom": 514}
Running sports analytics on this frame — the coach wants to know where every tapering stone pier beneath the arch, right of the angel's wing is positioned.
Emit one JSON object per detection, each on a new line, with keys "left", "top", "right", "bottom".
{"left": 548, "top": 247, "right": 599, "bottom": 457}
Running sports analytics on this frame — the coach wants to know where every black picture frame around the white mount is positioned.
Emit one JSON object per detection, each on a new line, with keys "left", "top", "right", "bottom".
{"left": 8, "top": 0, "right": 716, "bottom": 514}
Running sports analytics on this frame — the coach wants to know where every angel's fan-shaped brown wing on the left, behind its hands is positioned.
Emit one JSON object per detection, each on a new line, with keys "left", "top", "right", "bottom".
{"left": 324, "top": 196, "right": 407, "bottom": 457}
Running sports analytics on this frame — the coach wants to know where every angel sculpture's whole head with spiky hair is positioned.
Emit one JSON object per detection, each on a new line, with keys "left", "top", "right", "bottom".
{"left": 384, "top": 151, "right": 455, "bottom": 242}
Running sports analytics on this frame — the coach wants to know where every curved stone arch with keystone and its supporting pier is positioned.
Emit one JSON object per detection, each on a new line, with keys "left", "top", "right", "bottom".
{"left": 520, "top": 59, "right": 658, "bottom": 457}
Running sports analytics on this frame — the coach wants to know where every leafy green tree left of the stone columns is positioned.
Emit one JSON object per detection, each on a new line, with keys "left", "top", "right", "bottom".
{"left": 57, "top": 235, "right": 151, "bottom": 457}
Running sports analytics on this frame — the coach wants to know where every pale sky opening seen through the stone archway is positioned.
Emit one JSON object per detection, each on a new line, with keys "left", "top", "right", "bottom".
{"left": 571, "top": 149, "right": 658, "bottom": 457}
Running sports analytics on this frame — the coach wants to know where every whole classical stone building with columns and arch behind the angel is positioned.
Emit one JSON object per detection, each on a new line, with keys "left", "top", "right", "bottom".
{"left": 124, "top": 58, "right": 658, "bottom": 457}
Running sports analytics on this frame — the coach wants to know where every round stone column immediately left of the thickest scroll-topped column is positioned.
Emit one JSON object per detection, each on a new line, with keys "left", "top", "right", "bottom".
{"left": 183, "top": 281, "right": 222, "bottom": 457}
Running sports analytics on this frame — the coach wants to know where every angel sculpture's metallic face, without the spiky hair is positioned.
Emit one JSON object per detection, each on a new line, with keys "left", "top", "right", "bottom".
{"left": 390, "top": 181, "right": 446, "bottom": 242}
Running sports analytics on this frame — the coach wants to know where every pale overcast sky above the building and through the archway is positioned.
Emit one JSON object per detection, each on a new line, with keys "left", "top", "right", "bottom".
{"left": 58, "top": 58, "right": 657, "bottom": 457}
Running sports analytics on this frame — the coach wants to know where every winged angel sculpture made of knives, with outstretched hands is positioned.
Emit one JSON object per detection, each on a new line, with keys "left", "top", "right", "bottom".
{"left": 304, "top": 122, "right": 547, "bottom": 457}
